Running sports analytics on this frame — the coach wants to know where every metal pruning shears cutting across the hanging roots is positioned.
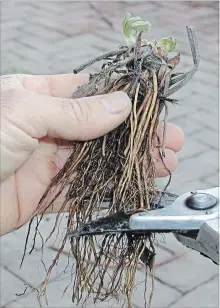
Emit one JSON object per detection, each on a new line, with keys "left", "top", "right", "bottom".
{"left": 69, "top": 187, "right": 219, "bottom": 264}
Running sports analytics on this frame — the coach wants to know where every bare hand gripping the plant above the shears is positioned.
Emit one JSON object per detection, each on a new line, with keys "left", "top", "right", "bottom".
{"left": 0, "top": 74, "right": 184, "bottom": 234}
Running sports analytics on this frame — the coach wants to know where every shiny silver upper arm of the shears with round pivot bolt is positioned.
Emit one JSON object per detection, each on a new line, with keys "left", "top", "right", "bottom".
{"left": 129, "top": 188, "right": 219, "bottom": 232}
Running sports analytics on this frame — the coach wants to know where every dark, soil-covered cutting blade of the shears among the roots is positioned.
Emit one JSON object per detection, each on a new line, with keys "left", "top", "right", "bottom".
{"left": 68, "top": 191, "right": 178, "bottom": 237}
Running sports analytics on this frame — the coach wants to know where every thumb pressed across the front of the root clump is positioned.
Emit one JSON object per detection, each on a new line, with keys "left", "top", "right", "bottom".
{"left": 27, "top": 92, "right": 131, "bottom": 140}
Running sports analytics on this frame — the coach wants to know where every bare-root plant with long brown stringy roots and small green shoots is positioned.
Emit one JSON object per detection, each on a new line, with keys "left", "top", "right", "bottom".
{"left": 21, "top": 15, "right": 199, "bottom": 308}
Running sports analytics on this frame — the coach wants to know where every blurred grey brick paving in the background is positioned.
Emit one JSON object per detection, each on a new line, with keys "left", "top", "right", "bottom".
{"left": 1, "top": 1, "right": 218, "bottom": 308}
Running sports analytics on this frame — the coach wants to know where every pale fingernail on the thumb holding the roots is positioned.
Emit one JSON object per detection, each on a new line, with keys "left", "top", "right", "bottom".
{"left": 102, "top": 91, "right": 131, "bottom": 114}
